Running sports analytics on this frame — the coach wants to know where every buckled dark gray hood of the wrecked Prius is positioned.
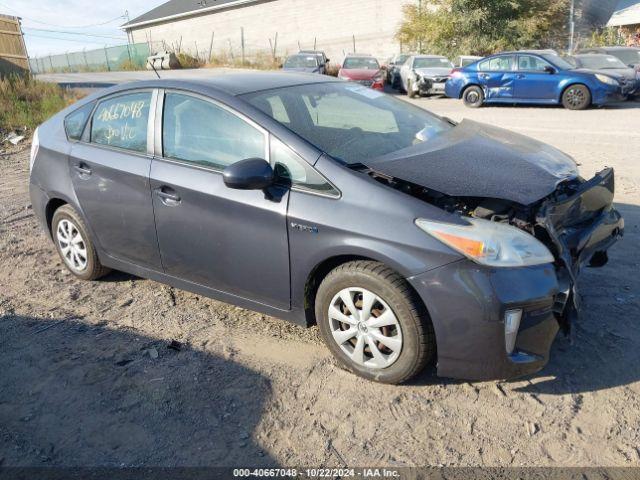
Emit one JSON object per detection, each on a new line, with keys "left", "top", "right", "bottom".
{"left": 363, "top": 120, "right": 578, "bottom": 205}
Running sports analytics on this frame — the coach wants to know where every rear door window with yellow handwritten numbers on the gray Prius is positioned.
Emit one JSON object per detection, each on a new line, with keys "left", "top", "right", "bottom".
{"left": 91, "top": 92, "right": 151, "bottom": 153}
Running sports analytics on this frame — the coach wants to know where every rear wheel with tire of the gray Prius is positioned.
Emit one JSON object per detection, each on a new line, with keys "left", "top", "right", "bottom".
{"left": 51, "top": 205, "right": 110, "bottom": 280}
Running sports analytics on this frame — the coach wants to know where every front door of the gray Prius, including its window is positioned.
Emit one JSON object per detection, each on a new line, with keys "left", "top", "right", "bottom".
{"left": 151, "top": 92, "right": 290, "bottom": 309}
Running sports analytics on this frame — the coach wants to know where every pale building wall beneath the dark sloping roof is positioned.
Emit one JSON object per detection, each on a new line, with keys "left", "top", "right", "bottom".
{"left": 128, "top": 0, "right": 413, "bottom": 63}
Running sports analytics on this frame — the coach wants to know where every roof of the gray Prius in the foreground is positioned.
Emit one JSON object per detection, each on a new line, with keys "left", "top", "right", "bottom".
{"left": 95, "top": 72, "right": 340, "bottom": 96}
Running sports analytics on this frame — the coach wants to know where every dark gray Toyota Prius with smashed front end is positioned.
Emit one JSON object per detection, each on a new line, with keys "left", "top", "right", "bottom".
{"left": 30, "top": 73, "right": 624, "bottom": 383}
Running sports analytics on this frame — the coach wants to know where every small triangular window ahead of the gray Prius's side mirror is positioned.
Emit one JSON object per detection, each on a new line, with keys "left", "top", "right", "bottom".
{"left": 271, "top": 137, "right": 339, "bottom": 196}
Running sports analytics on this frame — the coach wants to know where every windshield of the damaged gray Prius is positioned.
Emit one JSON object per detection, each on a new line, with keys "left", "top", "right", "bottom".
{"left": 243, "top": 82, "right": 453, "bottom": 165}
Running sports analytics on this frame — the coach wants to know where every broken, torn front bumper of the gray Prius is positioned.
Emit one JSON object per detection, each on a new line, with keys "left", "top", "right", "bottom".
{"left": 409, "top": 169, "right": 624, "bottom": 380}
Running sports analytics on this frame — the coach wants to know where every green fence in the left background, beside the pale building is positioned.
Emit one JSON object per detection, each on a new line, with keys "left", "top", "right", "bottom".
{"left": 29, "top": 43, "right": 149, "bottom": 73}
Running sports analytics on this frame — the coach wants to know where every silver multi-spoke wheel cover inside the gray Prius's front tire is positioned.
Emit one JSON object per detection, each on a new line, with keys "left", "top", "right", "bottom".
{"left": 328, "top": 287, "right": 402, "bottom": 369}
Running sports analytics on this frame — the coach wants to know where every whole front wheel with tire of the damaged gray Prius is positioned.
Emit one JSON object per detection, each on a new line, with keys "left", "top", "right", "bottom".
{"left": 315, "top": 261, "right": 436, "bottom": 384}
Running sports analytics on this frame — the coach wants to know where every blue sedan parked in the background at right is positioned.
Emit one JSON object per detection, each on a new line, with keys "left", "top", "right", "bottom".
{"left": 445, "top": 51, "right": 624, "bottom": 110}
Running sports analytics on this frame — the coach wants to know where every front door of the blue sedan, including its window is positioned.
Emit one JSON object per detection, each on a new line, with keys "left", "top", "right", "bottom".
{"left": 515, "top": 54, "right": 558, "bottom": 100}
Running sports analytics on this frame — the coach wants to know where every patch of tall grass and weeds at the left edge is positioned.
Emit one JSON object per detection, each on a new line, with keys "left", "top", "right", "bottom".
{"left": 0, "top": 76, "right": 81, "bottom": 132}
